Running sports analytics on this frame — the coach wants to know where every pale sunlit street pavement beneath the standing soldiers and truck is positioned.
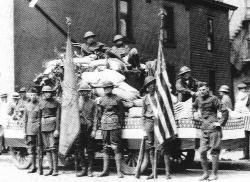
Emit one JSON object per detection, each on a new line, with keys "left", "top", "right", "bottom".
{"left": 0, "top": 154, "right": 250, "bottom": 182}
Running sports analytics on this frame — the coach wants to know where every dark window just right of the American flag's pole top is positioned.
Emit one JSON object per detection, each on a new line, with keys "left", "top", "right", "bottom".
{"left": 163, "top": 6, "right": 175, "bottom": 47}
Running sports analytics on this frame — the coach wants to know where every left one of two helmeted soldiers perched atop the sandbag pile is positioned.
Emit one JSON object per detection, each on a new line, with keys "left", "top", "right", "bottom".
{"left": 81, "top": 31, "right": 108, "bottom": 58}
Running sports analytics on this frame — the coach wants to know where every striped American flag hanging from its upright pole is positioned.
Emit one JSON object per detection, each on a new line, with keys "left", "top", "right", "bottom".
{"left": 154, "top": 34, "right": 177, "bottom": 144}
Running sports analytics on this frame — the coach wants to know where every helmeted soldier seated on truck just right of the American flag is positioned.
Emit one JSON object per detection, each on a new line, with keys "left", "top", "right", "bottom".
{"left": 175, "top": 66, "right": 199, "bottom": 102}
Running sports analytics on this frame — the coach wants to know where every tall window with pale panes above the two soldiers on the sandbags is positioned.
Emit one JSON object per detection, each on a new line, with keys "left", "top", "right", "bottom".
{"left": 117, "top": 0, "right": 132, "bottom": 40}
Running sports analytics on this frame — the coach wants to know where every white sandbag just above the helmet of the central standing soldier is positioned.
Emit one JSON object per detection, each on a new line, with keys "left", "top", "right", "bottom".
{"left": 99, "top": 69, "right": 125, "bottom": 85}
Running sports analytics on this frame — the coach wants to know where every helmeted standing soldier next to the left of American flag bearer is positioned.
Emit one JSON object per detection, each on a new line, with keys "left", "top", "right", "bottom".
{"left": 92, "top": 81, "right": 124, "bottom": 178}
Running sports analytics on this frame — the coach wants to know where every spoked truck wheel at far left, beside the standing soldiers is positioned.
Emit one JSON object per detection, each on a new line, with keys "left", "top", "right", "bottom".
{"left": 10, "top": 147, "right": 31, "bottom": 169}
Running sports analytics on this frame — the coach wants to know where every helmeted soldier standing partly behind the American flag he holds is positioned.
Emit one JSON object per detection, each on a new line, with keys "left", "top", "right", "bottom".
{"left": 142, "top": 76, "right": 171, "bottom": 179}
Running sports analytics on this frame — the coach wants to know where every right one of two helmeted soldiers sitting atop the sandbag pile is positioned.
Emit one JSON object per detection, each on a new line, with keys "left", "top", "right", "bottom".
{"left": 109, "top": 35, "right": 140, "bottom": 68}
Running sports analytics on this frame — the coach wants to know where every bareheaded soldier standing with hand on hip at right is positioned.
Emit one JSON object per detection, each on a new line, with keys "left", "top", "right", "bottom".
{"left": 193, "top": 83, "right": 228, "bottom": 181}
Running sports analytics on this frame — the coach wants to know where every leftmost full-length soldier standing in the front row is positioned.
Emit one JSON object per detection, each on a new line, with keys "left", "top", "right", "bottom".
{"left": 24, "top": 88, "right": 39, "bottom": 173}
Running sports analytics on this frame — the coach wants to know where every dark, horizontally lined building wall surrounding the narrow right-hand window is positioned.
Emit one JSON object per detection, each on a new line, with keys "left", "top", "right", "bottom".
{"left": 190, "top": 5, "right": 231, "bottom": 94}
